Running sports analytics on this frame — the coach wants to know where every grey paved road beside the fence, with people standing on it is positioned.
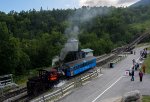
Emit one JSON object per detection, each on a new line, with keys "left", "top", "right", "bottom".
{"left": 59, "top": 47, "right": 150, "bottom": 102}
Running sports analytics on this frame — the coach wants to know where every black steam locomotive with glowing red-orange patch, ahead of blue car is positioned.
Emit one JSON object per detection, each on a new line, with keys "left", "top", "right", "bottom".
{"left": 27, "top": 68, "right": 59, "bottom": 97}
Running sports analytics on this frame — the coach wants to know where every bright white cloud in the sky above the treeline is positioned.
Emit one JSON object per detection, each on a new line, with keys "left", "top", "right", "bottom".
{"left": 80, "top": 0, "right": 139, "bottom": 7}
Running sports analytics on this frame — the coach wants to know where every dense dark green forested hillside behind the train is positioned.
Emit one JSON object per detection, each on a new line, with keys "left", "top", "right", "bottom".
{"left": 0, "top": 6, "right": 150, "bottom": 75}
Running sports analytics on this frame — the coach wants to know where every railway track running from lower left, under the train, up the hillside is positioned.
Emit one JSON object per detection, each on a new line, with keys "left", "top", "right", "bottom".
{"left": 0, "top": 34, "right": 149, "bottom": 102}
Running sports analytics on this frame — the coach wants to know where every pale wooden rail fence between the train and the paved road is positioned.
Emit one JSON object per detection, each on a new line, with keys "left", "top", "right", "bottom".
{"left": 31, "top": 68, "right": 101, "bottom": 102}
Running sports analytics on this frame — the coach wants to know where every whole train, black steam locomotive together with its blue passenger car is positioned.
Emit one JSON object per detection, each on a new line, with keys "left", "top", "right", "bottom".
{"left": 27, "top": 51, "right": 96, "bottom": 96}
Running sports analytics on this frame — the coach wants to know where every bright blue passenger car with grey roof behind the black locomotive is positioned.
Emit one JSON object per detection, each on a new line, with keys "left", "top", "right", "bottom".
{"left": 65, "top": 56, "right": 96, "bottom": 77}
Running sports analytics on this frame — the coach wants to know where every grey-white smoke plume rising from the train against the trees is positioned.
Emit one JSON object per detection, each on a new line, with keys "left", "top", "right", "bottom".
{"left": 60, "top": 7, "right": 109, "bottom": 60}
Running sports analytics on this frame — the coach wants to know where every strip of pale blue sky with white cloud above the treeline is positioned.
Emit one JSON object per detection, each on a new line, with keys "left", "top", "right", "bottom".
{"left": 0, "top": 0, "right": 139, "bottom": 13}
